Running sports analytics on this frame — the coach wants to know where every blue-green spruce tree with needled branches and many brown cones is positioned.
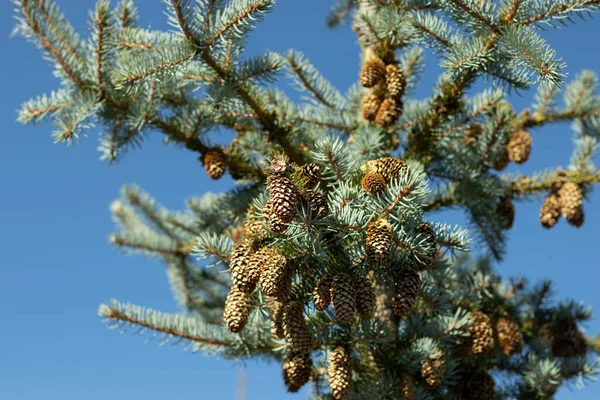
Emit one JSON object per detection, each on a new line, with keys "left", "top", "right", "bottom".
{"left": 13, "top": 0, "right": 600, "bottom": 400}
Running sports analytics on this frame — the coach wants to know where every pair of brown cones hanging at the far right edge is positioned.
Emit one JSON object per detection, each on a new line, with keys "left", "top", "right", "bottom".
{"left": 540, "top": 173, "right": 585, "bottom": 229}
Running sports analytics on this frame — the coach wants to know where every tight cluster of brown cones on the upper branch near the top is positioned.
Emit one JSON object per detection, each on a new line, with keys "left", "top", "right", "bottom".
{"left": 360, "top": 57, "right": 406, "bottom": 128}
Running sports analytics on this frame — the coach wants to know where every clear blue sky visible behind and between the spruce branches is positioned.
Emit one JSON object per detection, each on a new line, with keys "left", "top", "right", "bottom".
{"left": 0, "top": 0, "right": 600, "bottom": 400}
